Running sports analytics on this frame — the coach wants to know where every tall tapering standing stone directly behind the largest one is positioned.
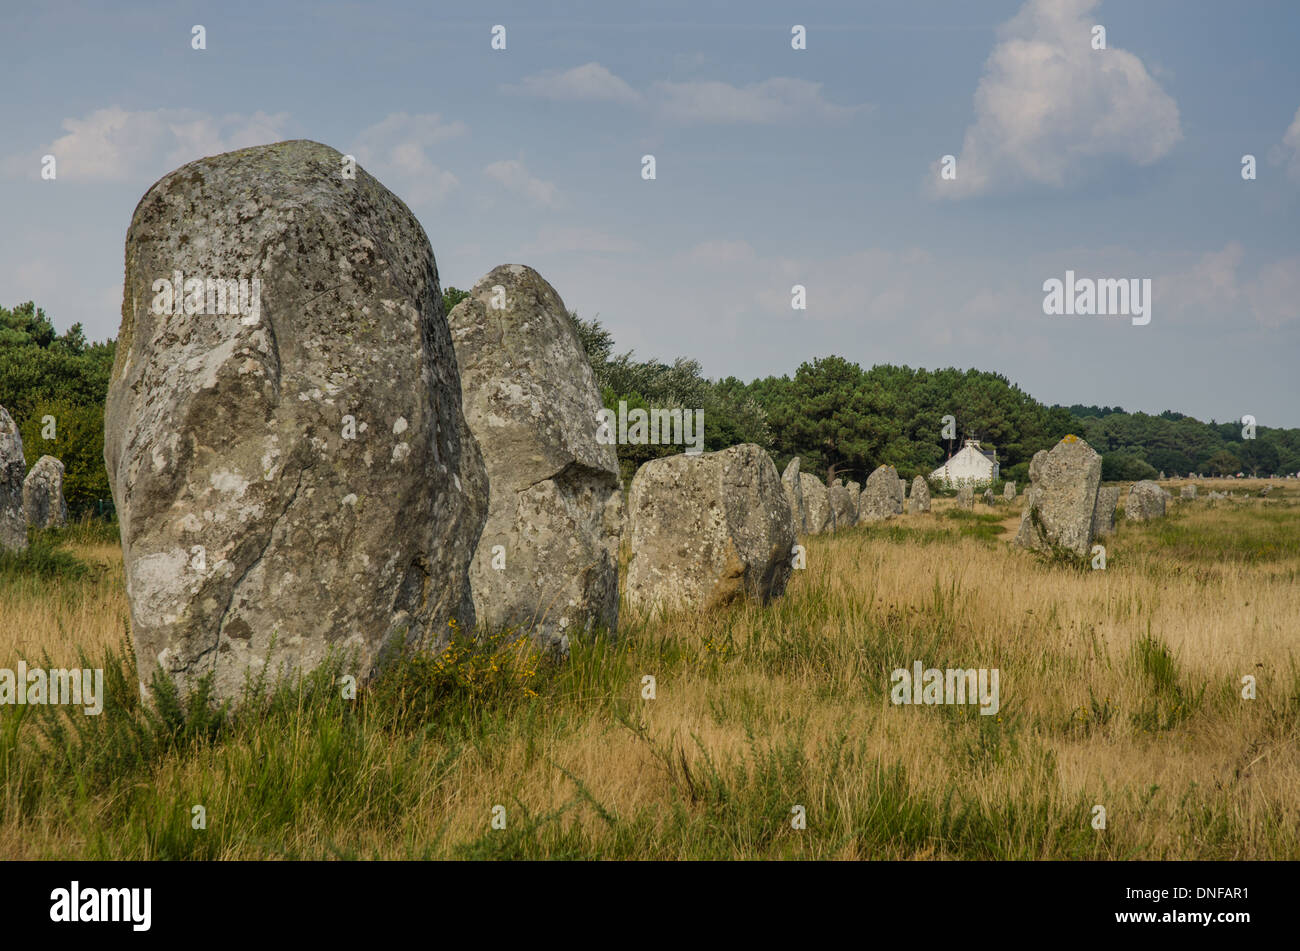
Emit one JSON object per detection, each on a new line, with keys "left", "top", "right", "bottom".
{"left": 447, "top": 264, "right": 621, "bottom": 653}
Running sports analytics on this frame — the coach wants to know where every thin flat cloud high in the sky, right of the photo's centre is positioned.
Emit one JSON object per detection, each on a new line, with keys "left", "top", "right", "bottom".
{"left": 651, "top": 77, "right": 870, "bottom": 123}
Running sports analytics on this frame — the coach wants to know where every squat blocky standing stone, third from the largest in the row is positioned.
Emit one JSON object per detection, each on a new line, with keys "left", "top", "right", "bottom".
{"left": 627, "top": 443, "right": 796, "bottom": 612}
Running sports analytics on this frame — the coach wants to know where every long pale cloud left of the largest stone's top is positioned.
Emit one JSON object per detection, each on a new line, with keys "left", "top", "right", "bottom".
{"left": 5, "top": 105, "right": 289, "bottom": 182}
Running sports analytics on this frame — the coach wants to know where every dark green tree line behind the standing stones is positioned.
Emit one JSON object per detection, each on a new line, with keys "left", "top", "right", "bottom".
{"left": 0, "top": 297, "right": 1300, "bottom": 513}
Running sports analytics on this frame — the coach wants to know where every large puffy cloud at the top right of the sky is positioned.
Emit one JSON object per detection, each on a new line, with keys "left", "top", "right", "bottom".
{"left": 928, "top": 0, "right": 1182, "bottom": 197}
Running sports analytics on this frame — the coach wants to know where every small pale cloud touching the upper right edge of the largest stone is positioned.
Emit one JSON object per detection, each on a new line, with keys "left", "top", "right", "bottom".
{"left": 352, "top": 112, "right": 467, "bottom": 205}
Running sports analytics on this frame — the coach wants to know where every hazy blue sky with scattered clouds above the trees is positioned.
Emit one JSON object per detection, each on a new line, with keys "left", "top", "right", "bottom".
{"left": 0, "top": 0, "right": 1300, "bottom": 426}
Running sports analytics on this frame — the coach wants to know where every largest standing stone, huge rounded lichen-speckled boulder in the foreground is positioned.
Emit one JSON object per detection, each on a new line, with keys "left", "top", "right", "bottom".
{"left": 104, "top": 140, "right": 488, "bottom": 700}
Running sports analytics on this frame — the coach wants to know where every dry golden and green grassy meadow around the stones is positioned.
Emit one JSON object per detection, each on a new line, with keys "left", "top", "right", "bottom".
{"left": 0, "top": 479, "right": 1300, "bottom": 859}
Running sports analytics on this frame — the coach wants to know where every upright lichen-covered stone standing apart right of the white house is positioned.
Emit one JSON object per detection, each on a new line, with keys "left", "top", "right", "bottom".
{"left": 1015, "top": 435, "right": 1101, "bottom": 557}
